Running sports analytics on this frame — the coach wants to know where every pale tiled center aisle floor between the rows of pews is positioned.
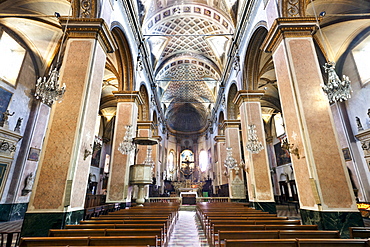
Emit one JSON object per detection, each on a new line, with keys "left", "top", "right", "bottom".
{"left": 168, "top": 209, "right": 209, "bottom": 247}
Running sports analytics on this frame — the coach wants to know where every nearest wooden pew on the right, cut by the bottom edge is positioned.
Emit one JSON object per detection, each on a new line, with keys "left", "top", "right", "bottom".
{"left": 225, "top": 239, "right": 369, "bottom": 247}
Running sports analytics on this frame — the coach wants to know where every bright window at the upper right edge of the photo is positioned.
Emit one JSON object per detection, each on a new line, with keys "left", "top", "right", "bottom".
{"left": 352, "top": 35, "right": 370, "bottom": 84}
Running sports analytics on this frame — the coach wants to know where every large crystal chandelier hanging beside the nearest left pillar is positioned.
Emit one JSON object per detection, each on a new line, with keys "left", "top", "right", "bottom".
{"left": 35, "top": 68, "right": 66, "bottom": 106}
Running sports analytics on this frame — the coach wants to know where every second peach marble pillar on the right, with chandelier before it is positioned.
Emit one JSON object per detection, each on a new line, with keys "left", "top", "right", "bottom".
{"left": 234, "top": 90, "right": 276, "bottom": 214}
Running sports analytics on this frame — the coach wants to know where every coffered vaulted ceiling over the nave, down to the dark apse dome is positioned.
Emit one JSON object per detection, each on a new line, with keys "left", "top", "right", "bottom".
{"left": 141, "top": 0, "right": 235, "bottom": 132}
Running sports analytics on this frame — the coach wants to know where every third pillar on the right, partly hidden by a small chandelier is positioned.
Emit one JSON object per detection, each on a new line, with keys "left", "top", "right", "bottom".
{"left": 222, "top": 120, "right": 245, "bottom": 201}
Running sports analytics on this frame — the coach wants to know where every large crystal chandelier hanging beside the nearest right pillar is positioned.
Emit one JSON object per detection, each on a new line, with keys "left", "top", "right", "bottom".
{"left": 321, "top": 62, "right": 352, "bottom": 103}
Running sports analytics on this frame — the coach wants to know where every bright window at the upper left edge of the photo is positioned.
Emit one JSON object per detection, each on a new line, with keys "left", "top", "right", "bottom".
{"left": 0, "top": 30, "right": 26, "bottom": 86}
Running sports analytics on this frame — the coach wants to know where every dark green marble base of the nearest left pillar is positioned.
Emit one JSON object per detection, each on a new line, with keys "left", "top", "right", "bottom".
{"left": 21, "top": 210, "right": 84, "bottom": 237}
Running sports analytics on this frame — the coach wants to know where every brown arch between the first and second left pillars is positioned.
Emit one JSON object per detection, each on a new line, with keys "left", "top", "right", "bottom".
{"left": 112, "top": 23, "right": 135, "bottom": 91}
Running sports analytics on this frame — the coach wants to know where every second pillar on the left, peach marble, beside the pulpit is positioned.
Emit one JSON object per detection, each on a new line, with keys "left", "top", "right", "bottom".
{"left": 106, "top": 91, "right": 142, "bottom": 208}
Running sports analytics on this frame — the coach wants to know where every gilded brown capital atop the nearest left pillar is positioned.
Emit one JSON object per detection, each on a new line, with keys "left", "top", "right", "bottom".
{"left": 60, "top": 17, "right": 117, "bottom": 53}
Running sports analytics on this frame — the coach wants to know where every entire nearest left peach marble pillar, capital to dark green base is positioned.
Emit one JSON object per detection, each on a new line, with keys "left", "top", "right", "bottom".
{"left": 21, "top": 19, "right": 115, "bottom": 236}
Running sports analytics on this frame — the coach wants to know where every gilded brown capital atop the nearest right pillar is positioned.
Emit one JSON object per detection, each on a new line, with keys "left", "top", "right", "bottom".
{"left": 262, "top": 17, "right": 321, "bottom": 52}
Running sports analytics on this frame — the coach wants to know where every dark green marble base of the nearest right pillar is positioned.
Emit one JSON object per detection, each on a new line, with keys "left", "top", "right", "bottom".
{"left": 300, "top": 209, "right": 364, "bottom": 238}
